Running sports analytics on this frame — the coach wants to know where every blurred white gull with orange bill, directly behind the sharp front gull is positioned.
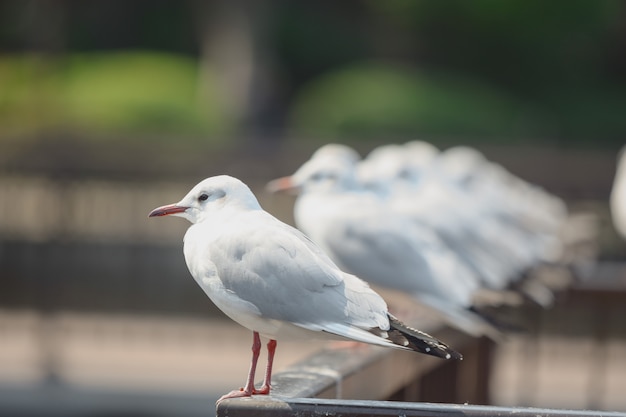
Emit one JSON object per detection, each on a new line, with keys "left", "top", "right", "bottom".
{"left": 268, "top": 146, "right": 508, "bottom": 340}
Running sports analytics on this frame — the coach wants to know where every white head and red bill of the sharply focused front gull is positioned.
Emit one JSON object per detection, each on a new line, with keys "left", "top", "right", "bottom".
{"left": 148, "top": 175, "right": 261, "bottom": 224}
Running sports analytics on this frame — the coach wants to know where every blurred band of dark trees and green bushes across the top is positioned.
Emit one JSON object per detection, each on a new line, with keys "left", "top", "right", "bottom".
{"left": 0, "top": 0, "right": 626, "bottom": 146}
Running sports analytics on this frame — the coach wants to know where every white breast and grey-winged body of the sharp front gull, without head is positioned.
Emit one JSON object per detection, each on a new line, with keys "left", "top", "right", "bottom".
{"left": 180, "top": 204, "right": 389, "bottom": 330}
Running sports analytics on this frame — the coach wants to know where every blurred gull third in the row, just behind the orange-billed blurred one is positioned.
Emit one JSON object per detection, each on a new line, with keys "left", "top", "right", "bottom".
{"left": 358, "top": 141, "right": 519, "bottom": 290}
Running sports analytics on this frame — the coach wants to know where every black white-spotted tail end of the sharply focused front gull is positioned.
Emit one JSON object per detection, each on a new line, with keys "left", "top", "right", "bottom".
{"left": 387, "top": 314, "right": 463, "bottom": 359}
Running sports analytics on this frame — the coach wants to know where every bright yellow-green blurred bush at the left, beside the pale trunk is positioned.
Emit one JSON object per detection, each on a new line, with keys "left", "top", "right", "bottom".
{"left": 0, "top": 52, "right": 229, "bottom": 140}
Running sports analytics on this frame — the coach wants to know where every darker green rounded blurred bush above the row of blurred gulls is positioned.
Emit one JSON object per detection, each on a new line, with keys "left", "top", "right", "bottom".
{"left": 290, "top": 64, "right": 541, "bottom": 141}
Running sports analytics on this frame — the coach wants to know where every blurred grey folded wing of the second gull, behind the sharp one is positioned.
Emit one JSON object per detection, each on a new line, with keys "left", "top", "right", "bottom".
{"left": 327, "top": 218, "right": 478, "bottom": 304}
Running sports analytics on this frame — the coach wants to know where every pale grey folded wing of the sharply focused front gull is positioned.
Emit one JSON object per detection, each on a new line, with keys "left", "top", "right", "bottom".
{"left": 215, "top": 218, "right": 388, "bottom": 330}
